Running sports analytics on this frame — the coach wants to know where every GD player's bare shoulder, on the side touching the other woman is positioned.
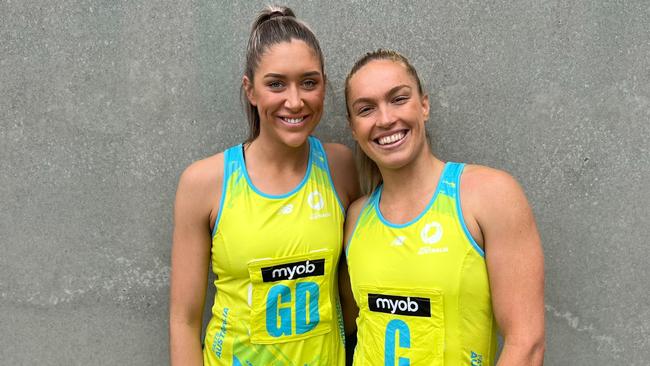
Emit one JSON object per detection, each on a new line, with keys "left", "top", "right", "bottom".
{"left": 323, "top": 143, "right": 359, "bottom": 208}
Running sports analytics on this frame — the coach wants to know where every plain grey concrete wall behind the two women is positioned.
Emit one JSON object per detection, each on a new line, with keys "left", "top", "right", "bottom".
{"left": 0, "top": 0, "right": 650, "bottom": 366}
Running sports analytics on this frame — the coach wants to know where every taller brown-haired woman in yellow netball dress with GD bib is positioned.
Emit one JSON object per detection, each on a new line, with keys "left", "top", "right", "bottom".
{"left": 170, "top": 7, "right": 358, "bottom": 365}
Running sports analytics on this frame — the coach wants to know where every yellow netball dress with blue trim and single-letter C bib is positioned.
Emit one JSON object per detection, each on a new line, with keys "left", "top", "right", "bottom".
{"left": 346, "top": 163, "right": 496, "bottom": 366}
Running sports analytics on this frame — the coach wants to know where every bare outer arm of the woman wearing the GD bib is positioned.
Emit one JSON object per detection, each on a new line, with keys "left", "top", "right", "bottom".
{"left": 169, "top": 156, "right": 223, "bottom": 366}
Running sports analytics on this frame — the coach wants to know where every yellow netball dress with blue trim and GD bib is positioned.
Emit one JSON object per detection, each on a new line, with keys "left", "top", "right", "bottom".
{"left": 203, "top": 137, "right": 345, "bottom": 366}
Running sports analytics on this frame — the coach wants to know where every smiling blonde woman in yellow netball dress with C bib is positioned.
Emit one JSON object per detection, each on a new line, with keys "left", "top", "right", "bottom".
{"left": 341, "top": 50, "right": 544, "bottom": 366}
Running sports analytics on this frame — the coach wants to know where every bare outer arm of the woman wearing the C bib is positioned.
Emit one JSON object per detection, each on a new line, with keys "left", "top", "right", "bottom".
{"left": 462, "top": 167, "right": 545, "bottom": 366}
